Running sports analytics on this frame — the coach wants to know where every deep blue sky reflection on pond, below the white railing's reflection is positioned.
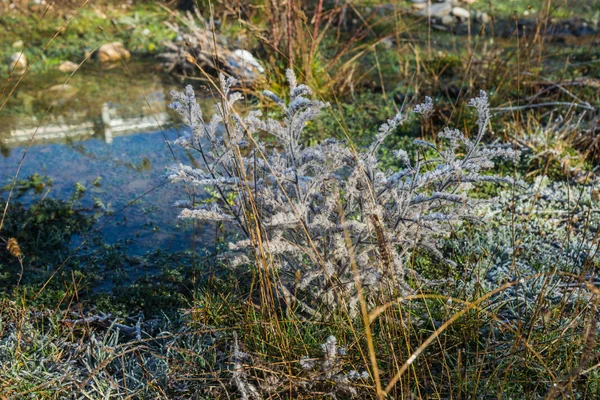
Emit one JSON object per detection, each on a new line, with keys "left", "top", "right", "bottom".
{"left": 0, "top": 129, "right": 214, "bottom": 254}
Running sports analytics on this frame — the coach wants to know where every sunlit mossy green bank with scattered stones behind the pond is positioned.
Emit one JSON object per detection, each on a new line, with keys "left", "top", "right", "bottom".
{"left": 0, "top": 2, "right": 175, "bottom": 75}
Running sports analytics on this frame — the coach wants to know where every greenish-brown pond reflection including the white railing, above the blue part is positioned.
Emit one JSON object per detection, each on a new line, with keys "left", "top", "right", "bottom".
{"left": 0, "top": 64, "right": 171, "bottom": 152}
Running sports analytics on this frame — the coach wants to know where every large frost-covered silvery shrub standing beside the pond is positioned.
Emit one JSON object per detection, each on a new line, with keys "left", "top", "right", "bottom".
{"left": 169, "top": 70, "right": 517, "bottom": 315}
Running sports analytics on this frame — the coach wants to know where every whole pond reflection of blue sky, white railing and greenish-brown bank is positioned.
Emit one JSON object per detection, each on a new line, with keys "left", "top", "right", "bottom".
{"left": 0, "top": 62, "right": 214, "bottom": 254}
